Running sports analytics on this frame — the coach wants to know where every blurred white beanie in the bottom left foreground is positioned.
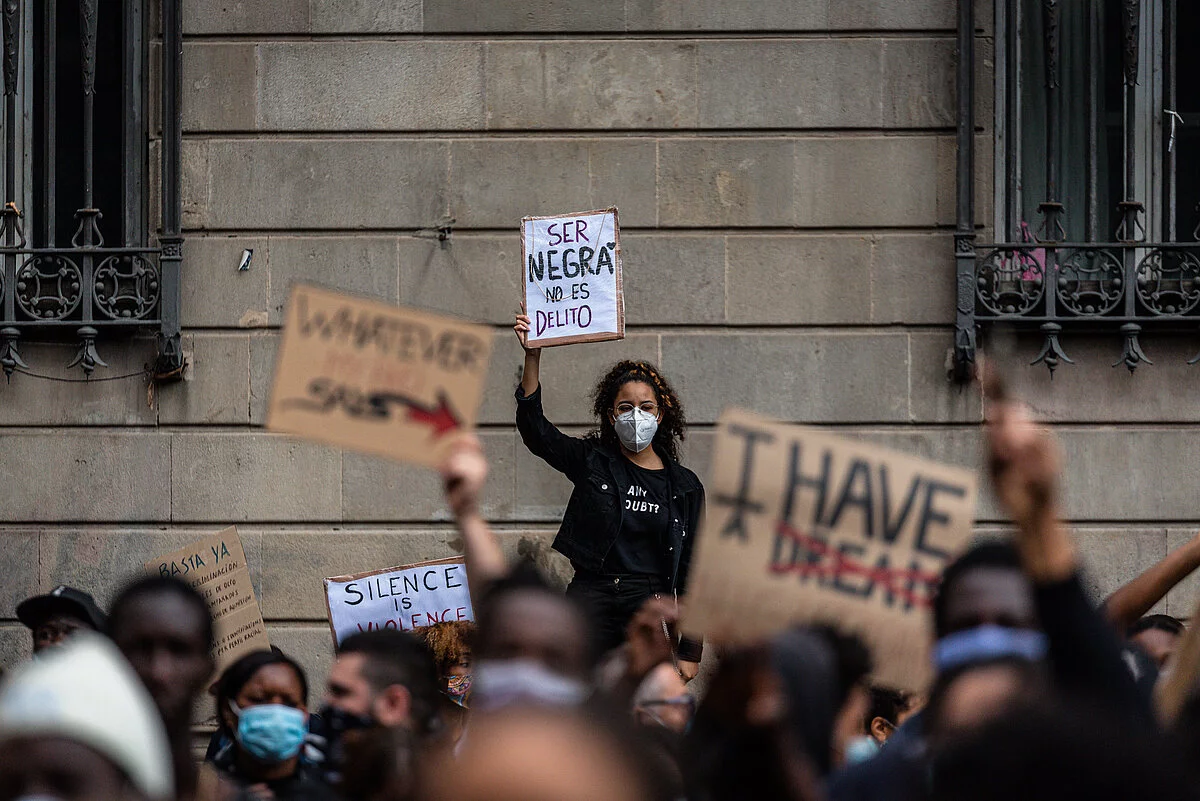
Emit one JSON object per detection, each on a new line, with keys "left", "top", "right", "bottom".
{"left": 0, "top": 632, "right": 174, "bottom": 799}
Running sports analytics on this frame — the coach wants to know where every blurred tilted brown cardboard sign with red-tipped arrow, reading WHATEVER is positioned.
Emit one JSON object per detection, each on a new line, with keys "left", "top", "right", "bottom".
{"left": 266, "top": 285, "right": 492, "bottom": 466}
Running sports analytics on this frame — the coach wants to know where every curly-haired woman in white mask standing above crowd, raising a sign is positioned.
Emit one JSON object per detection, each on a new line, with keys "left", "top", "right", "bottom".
{"left": 514, "top": 314, "right": 704, "bottom": 679}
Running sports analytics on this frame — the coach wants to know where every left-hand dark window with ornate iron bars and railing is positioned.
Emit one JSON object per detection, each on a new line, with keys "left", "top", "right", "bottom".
{"left": 0, "top": 0, "right": 182, "bottom": 377}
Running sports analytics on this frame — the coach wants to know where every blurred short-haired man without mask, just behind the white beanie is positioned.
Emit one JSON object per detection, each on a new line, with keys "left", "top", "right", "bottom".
{"left": 108, "top": 576, "right": 215, "bottom": 801}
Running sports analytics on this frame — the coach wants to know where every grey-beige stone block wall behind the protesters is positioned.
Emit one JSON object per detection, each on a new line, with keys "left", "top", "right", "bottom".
{"left": 0, "top": 0, "right": 1200, "bottom": 686}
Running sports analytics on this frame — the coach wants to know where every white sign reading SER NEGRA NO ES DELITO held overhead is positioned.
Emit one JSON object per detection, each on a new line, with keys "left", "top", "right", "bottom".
{"left": 521, "top": 209, "right": 625, "bottom": 348}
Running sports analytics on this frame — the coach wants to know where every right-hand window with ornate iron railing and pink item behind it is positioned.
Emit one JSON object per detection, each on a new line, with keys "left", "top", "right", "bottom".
{"left": 956, "top": 0, "right": 1200, "bottom": 371}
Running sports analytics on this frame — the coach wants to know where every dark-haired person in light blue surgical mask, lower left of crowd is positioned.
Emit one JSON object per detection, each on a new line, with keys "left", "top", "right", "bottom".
{"left": 212, "top": 650, "right": 331, "bottom": 801}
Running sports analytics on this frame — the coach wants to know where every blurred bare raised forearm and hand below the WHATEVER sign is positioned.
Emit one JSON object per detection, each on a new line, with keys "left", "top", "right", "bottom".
{"left": 442, "top": 435, "right": 509, "bottom": 600}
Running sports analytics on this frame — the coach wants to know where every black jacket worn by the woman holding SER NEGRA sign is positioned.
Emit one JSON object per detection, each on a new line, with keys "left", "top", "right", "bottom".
{"left": 516, "top": 386, "right": 704, "bottom": 595}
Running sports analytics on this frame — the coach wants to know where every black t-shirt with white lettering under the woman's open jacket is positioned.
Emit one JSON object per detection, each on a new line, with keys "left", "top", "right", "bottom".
{"left": 605, "top": 463, "right": 671, "bottom": 576}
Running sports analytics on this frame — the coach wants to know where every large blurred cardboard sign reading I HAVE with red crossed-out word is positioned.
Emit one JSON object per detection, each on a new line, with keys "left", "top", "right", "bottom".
{"left": 683, "top": 410, "right": 976, "bottom": 689}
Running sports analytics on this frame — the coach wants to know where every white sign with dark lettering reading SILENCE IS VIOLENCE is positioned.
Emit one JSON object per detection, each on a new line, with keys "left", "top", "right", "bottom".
{"left": 324, "top": 556, "right": 475, "bottom": 645}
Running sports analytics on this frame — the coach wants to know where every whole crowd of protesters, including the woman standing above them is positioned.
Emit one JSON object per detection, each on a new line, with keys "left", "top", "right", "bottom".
{"left": 0, "top": 326, "right": 1200, "bottom": 801}
